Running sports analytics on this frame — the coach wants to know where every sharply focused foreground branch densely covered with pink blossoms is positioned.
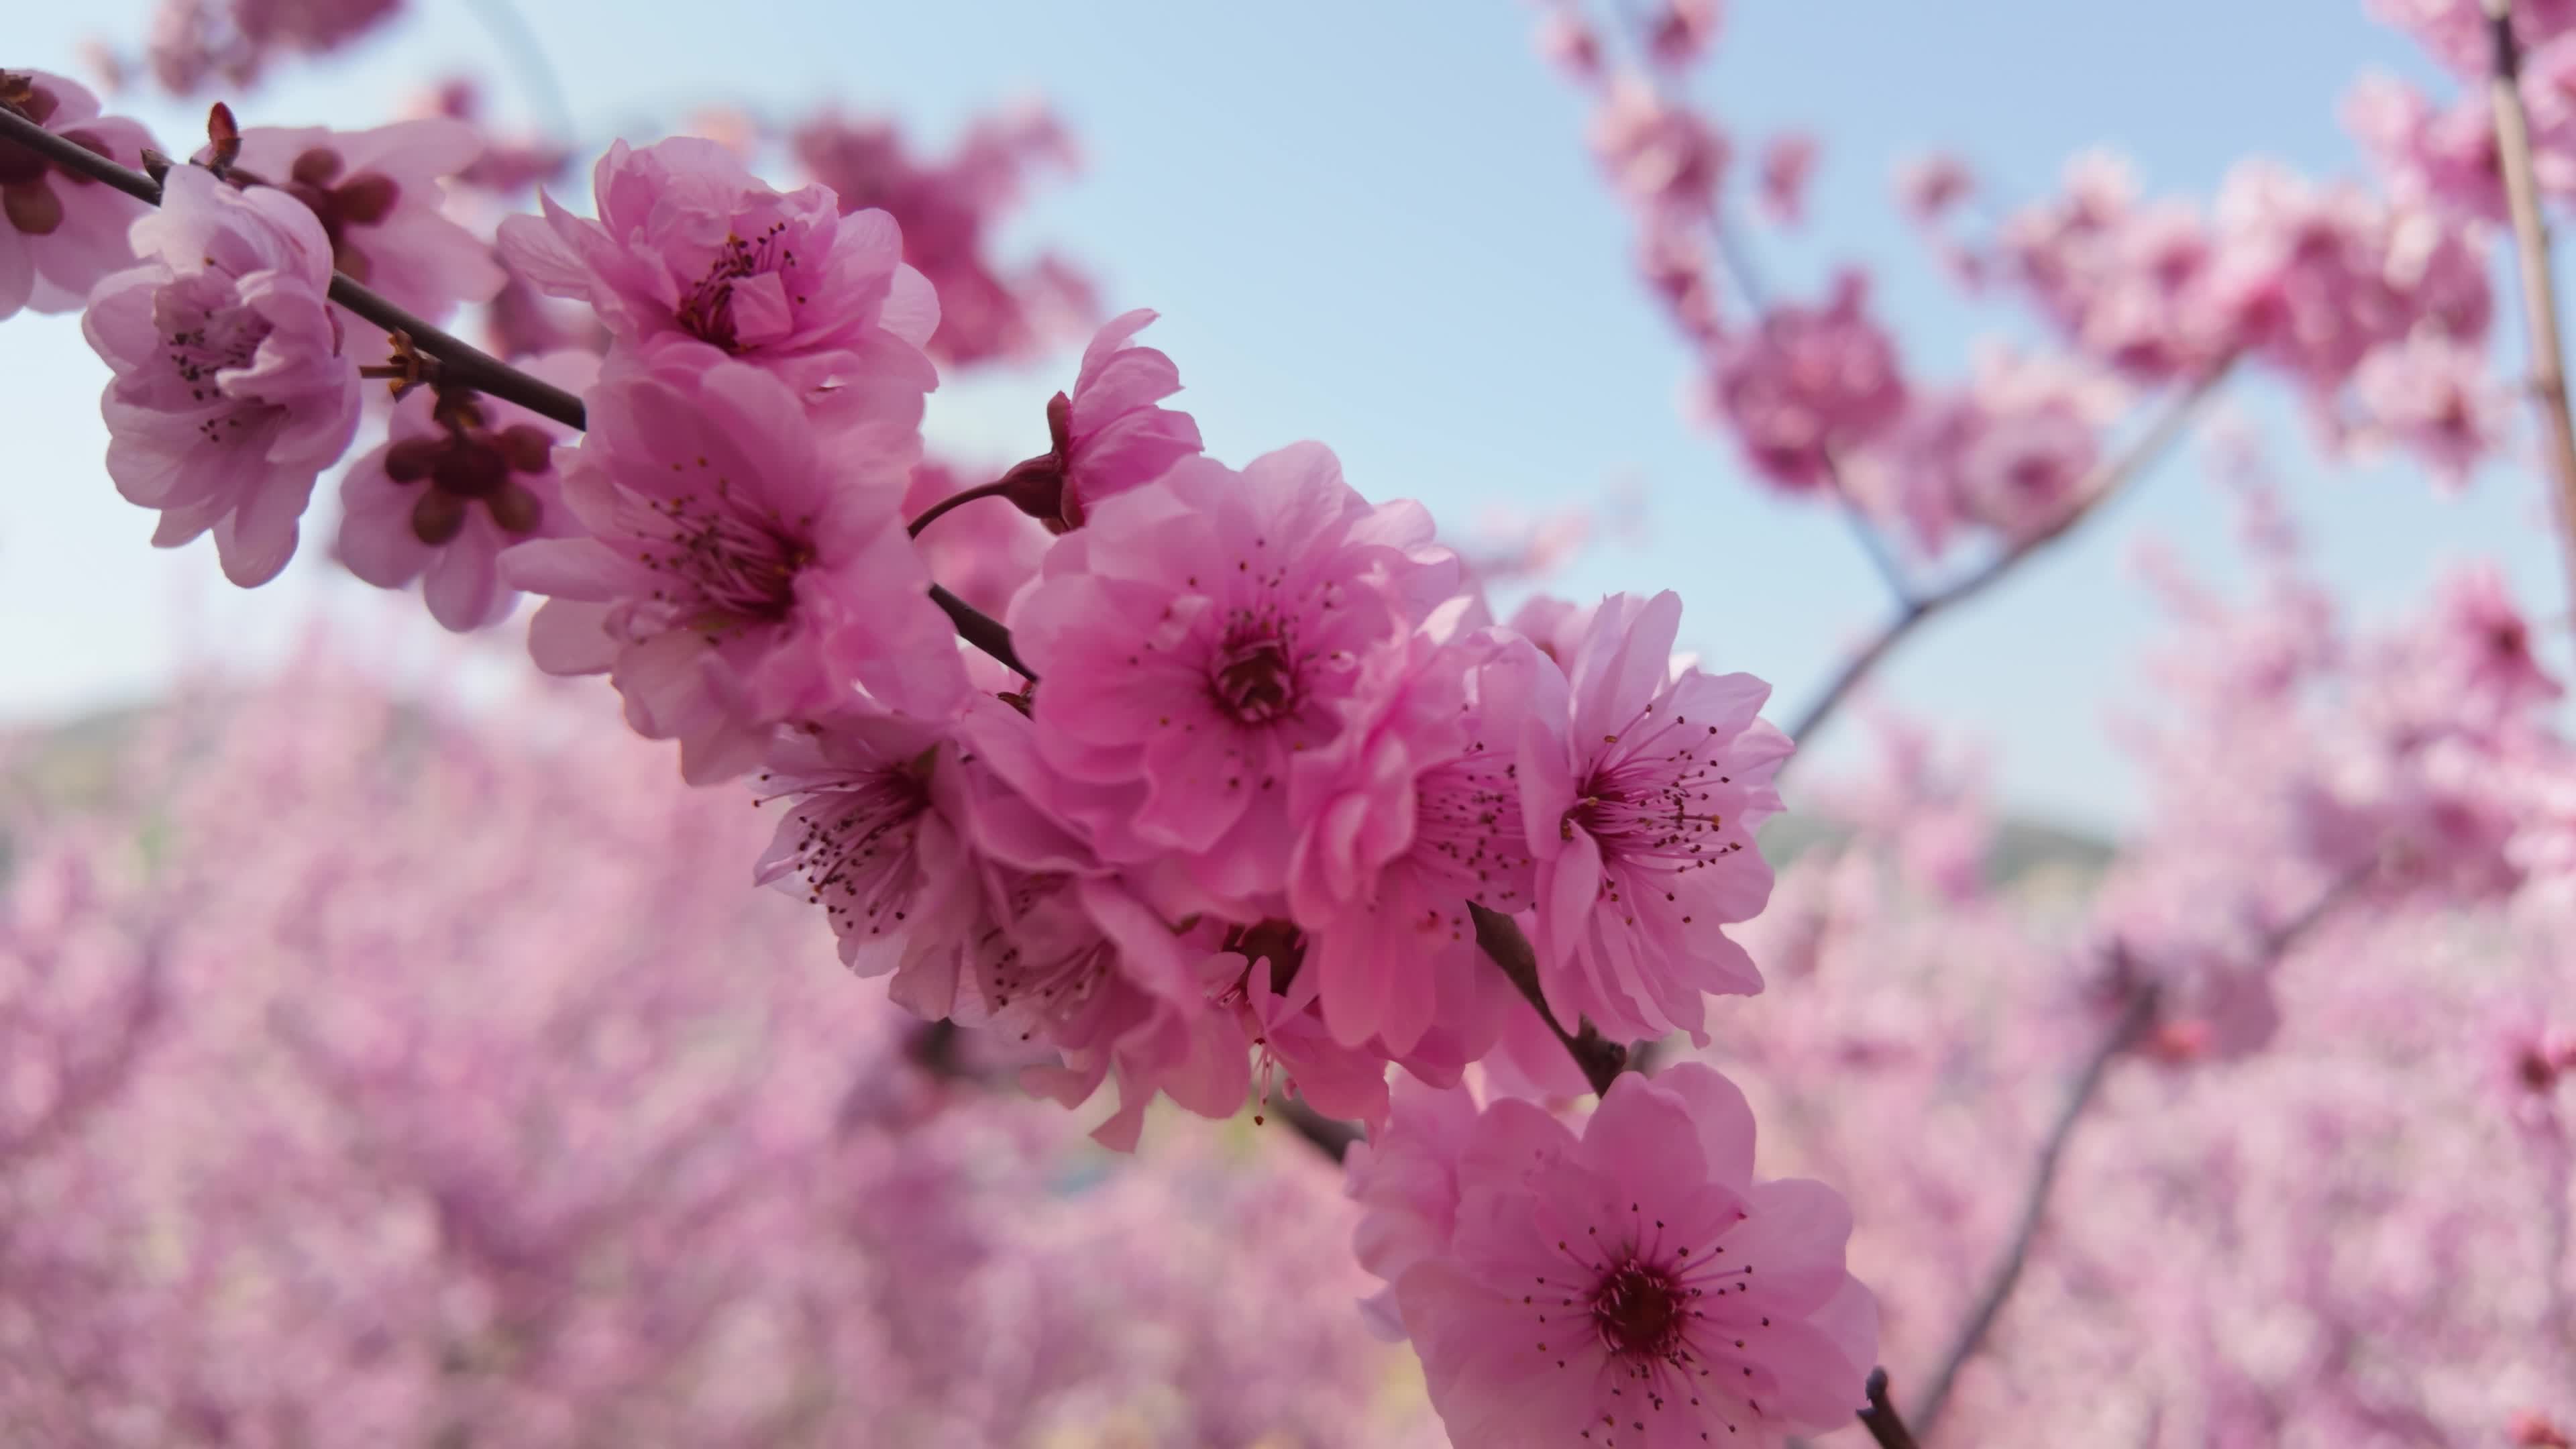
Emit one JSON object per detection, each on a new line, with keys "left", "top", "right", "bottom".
{"left": 0, "top": 50, "right": 1876, "bottom": 1434}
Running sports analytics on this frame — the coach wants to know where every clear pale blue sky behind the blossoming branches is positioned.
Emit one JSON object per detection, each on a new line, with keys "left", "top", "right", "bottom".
{"left": 0, "top": 0, "right": 2563, "bottom": 825}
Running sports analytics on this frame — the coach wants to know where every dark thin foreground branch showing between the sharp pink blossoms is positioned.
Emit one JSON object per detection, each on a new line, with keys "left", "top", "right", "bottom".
{"left": 0, "top": 93, "right": 1628, "bottom": 1119}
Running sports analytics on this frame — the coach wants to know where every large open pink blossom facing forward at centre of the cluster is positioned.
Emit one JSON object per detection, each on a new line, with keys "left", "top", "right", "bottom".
{"left": 1010, "top": 443, "right": 1456, "bottom": 915}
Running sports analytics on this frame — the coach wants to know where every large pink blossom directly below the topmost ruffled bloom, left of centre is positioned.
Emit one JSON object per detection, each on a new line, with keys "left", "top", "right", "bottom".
{"left": 502, "top": 345, "right": 963, "bottom": 784}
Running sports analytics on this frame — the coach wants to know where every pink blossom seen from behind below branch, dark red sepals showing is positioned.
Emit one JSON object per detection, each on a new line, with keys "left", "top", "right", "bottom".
{"left": 337, "top": 354, "right": 600, "bottom": 634}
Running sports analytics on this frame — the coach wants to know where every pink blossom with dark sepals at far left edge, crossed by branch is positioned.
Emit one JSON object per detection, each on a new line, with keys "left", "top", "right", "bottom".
{"left": 0, "top": 70, "right": 152, "bottom": 320}
